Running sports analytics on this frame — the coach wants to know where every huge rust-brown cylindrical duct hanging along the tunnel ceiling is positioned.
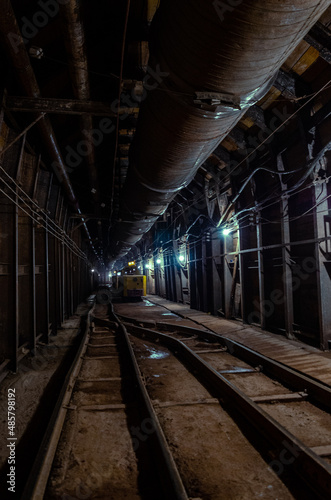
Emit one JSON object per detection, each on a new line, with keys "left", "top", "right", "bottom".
{"left": 110, "top": 0, "right": 330, "bottom": 260}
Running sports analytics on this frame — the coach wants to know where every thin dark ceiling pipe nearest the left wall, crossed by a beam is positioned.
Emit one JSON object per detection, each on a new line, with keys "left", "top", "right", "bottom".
{"left": 0, "top": 0, "right": 79, "bottom": 212}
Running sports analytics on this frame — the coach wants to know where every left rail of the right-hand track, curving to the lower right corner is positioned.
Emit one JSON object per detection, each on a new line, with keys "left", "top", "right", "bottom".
{"left": 126, "top": 325, "right": 331, "bottom": 499}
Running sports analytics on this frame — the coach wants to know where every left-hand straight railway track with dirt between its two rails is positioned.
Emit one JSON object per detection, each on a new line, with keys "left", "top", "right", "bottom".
{"left": 22, "top": 305, "right": 188, "bottom": 500}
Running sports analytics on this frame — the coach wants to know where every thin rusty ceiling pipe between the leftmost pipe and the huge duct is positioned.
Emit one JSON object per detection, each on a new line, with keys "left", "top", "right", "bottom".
{"left": 60, "top": 0, "right": 99, "bottom": 201}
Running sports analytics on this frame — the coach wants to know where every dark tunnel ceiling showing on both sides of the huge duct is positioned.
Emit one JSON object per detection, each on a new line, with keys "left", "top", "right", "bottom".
{"left": 1, "top": 0, "right": 331, "bottom": 270}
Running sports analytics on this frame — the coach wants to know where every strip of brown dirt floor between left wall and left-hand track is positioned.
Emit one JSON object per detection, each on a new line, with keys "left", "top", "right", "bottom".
{"left": 0, "top": 303, "right": 90, "bottom": 498}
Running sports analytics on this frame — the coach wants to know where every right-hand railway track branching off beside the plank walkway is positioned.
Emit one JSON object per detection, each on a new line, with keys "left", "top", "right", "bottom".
{"left": 116, "top": 316, "right": 331, "bottom": 499}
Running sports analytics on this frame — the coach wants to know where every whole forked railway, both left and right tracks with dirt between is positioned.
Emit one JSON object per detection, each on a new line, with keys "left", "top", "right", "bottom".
{"left": 22, "top": 305, "right": 331, "bottom": 500}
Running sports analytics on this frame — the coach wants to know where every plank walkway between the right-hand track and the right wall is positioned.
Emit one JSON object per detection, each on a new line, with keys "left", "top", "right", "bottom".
{"left": 126, "top": 295, "right": 331, "bottom": 385}
